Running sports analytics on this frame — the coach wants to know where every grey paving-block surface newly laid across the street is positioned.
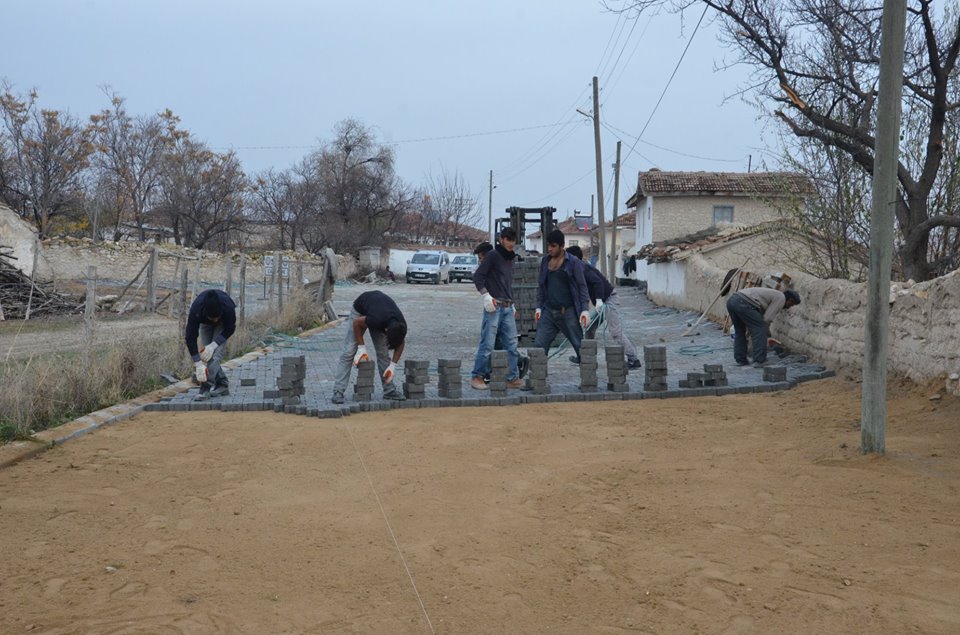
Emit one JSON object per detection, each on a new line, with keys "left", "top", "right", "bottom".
{"left": 146, "top": 283, "right": 834, "bottom": 417}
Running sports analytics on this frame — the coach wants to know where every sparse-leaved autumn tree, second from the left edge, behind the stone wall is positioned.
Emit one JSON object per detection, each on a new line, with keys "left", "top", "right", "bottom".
{"left": 90, "top": 89, "right": 169, "bottom": 241}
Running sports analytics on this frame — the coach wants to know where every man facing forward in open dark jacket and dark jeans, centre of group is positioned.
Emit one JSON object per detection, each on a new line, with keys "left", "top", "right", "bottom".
{"left": 533, "top": 229, "right": 590, "bottom": 364}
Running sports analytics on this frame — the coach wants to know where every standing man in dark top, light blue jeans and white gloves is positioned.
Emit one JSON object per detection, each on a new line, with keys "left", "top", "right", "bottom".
{"left": 470, "top": 227, "right": 523, "bottom": 390}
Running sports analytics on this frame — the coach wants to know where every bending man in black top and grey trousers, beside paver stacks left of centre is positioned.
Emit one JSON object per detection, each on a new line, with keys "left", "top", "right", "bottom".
{"left": 331, "top": 291, "right": 407, "bottom": 404}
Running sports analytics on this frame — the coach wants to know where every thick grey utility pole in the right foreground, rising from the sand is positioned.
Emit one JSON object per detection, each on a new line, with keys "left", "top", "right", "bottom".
{"left": 860, "top": 0, "right": 907, "bottom": 454}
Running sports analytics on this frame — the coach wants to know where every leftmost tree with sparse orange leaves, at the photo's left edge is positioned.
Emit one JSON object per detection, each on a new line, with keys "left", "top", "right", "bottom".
{"left": 0, "top": 83, "right": 93, "bottom": 237}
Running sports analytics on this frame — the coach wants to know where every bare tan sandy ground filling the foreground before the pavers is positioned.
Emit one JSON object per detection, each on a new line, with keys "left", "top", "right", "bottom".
{"left": 0, "top": 379, "right": 960, "bottom": 634}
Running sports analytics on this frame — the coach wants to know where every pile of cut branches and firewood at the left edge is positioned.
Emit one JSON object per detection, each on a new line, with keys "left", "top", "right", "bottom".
{"left": 0, "top": 246, "right": 84, "bottom": 320}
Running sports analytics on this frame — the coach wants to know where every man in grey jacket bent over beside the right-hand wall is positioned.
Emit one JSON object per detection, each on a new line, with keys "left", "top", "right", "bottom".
{"left": 727, "top": 287, "right": 800, "bottom": 367}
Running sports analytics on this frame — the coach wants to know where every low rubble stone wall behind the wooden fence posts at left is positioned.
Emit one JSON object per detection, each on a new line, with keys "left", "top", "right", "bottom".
{"left": 39, "top": 238, "right": 356, "bottom": 286}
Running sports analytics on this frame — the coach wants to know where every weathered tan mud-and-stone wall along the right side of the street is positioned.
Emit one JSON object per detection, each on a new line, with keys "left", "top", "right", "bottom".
{"left": 650, "top": 256, "right": 960, "bottom": 382}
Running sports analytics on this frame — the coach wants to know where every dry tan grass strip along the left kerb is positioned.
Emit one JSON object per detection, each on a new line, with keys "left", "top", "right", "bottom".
{"left": 0, "top": 292, "right": 323, "bottom": 441}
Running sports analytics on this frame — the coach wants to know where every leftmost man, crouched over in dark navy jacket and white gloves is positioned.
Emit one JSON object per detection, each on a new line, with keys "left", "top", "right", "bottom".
{"left": 184, "top": 289, "right": 237, "bottom": 399}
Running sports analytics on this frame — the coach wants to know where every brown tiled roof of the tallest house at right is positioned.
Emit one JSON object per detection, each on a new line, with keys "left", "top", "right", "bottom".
{"left": 627, "top": 170, "right": 814, "bottom": 207}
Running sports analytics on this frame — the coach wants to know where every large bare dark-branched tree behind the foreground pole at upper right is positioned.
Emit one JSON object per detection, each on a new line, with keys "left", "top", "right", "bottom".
{"left": 607, "top": 0, "right": 960, "bottom": 280}
